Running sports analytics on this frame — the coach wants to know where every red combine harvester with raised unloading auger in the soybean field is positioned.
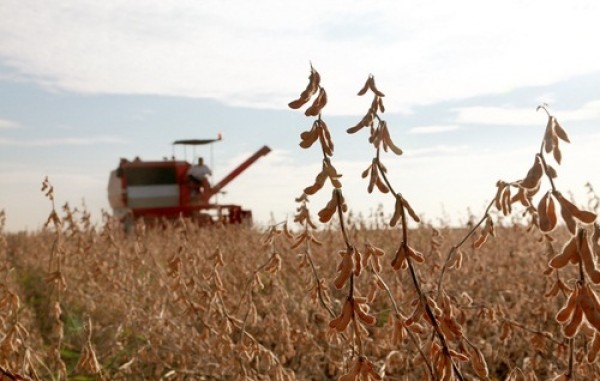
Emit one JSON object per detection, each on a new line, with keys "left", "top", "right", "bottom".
{"left": 108, "top": 137, "right": 271, "bottom": 224}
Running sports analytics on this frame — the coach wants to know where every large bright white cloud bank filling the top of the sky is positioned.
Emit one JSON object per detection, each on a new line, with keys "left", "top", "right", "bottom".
{"left": 0, "top": 0, "right": 600, "bottom": 114}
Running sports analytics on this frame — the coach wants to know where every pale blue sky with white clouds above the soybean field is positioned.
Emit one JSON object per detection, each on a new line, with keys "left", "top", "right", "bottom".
{"left": 0, "top": 0, "right": 600, "bottom": 231}
